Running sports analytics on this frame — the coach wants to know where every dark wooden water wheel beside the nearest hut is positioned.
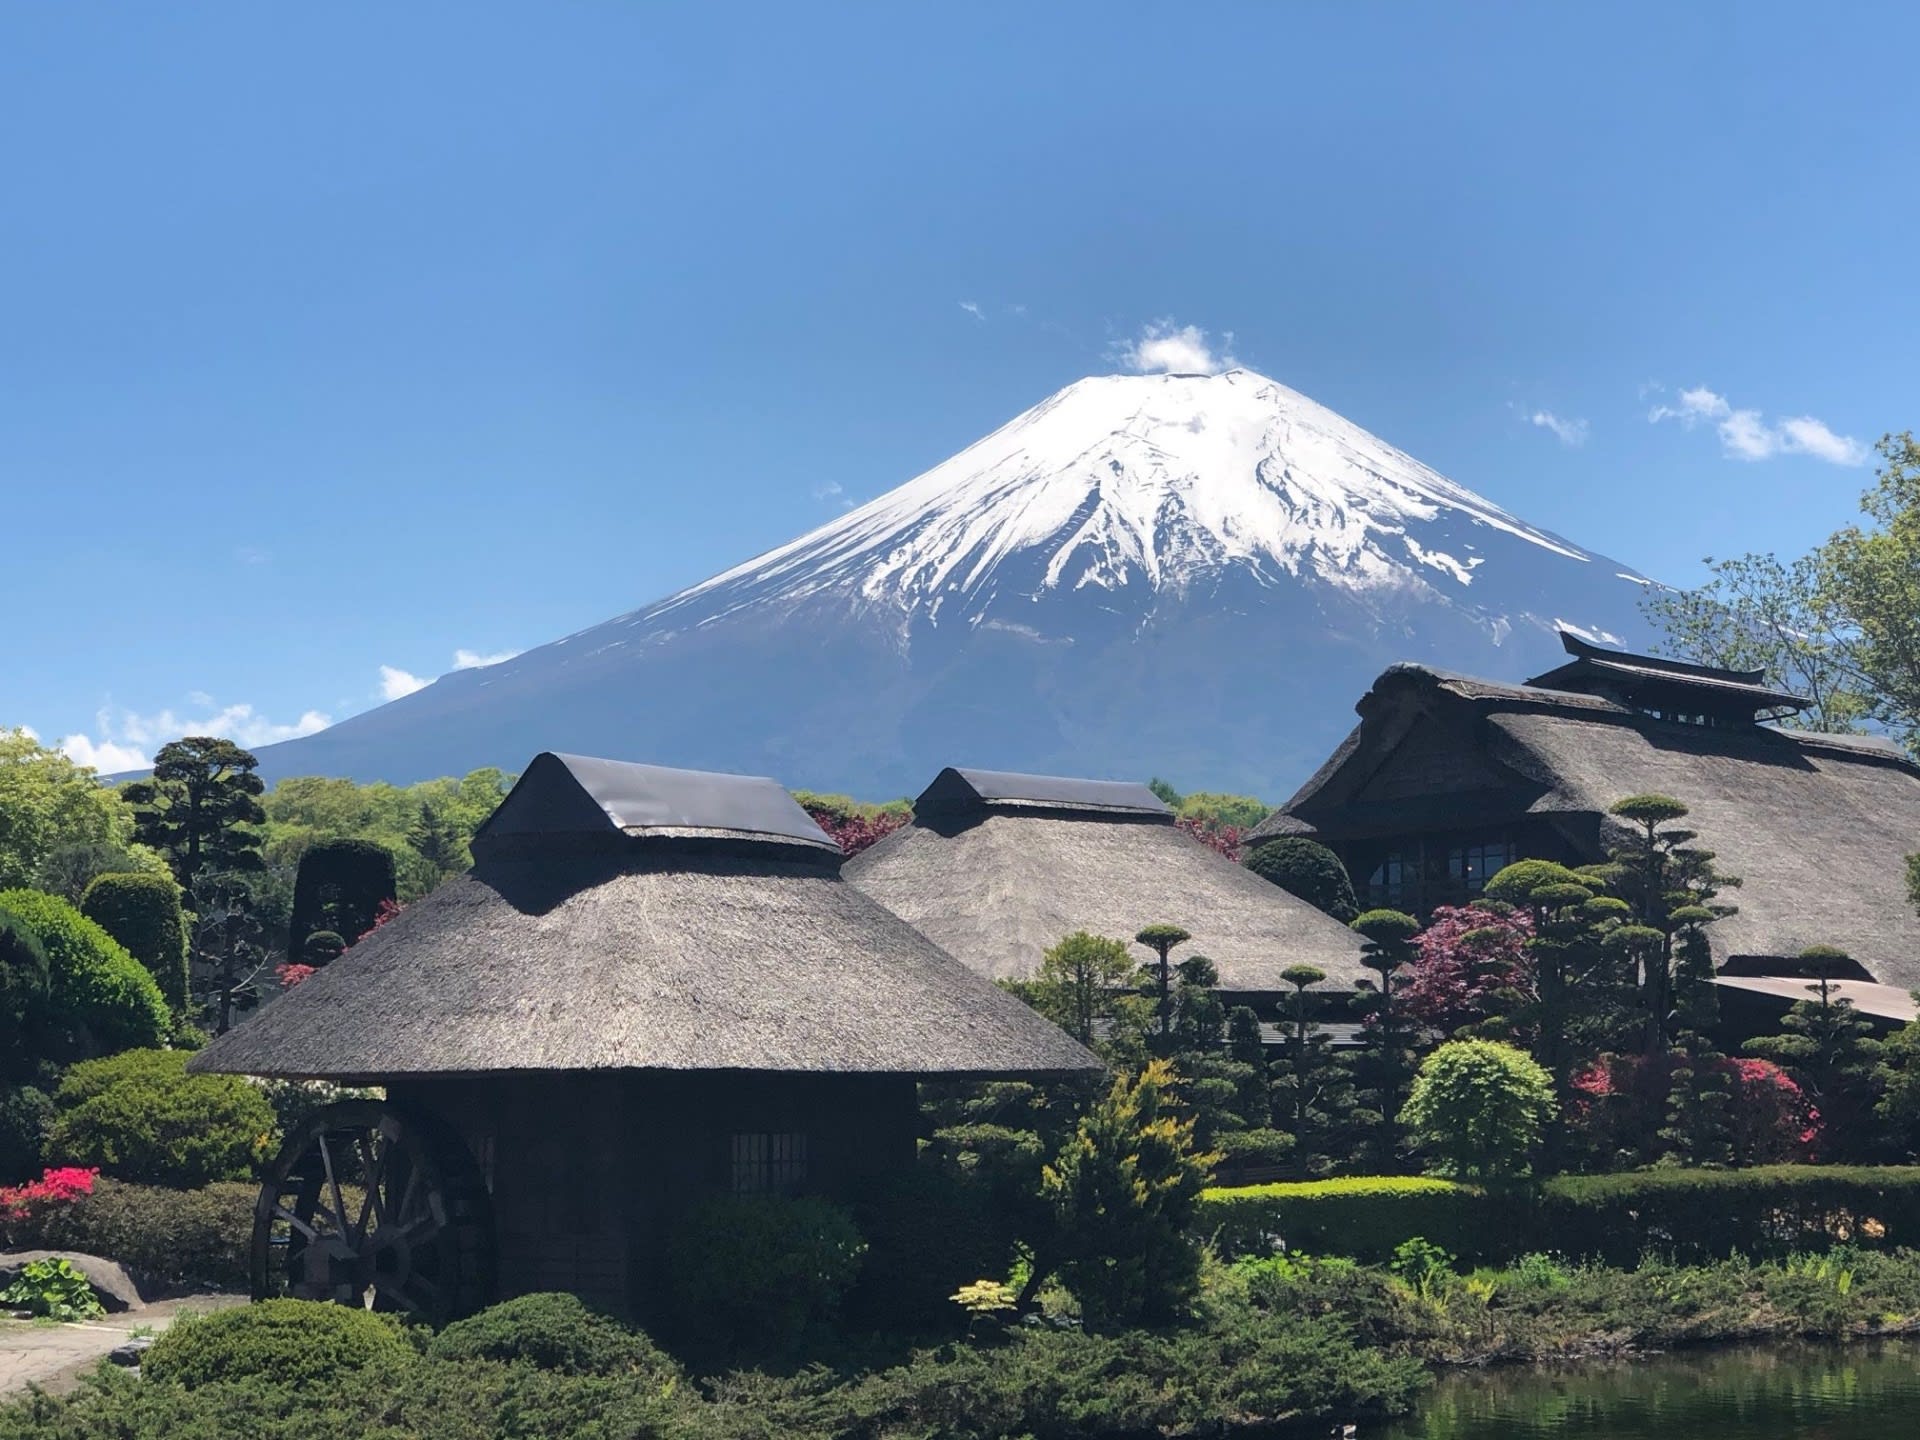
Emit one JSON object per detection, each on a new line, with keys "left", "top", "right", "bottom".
{"left": 253, "top": 1100, "right": 495, "bottom": 1325}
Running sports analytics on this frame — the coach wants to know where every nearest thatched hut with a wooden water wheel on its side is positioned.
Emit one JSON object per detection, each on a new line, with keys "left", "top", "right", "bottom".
{"left": 192, "top": 755, "right": 1100, "bottom": 1315}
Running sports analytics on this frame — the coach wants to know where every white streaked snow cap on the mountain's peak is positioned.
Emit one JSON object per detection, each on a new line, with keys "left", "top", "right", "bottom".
{"left": 643, "top": 369, "right": 1635, "bottom": 637}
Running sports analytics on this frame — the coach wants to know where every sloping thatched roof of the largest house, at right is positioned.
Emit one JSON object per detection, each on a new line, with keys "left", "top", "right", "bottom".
{"left": 1250, "top": 664, "right": 1920, "bottom": 989}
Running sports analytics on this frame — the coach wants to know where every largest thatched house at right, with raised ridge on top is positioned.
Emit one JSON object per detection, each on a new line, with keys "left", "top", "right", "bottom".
{"left": 1250, "top": 636, "right": 1920, "bottom": 989}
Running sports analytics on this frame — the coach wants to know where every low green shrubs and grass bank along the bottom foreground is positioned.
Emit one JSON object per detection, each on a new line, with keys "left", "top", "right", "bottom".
{"left": 11, "top": 1246, "right": 1920, "bottom": 1440}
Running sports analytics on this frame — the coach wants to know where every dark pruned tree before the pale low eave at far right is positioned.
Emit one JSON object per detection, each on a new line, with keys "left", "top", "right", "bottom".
{"left": 1745, "top": 945, "right": 1882, "bottom": 1158}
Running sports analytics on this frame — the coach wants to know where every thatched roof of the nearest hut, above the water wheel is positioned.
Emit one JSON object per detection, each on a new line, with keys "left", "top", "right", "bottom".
{"left": 192, "top": 755, "right": 1098, "bottom": 1081}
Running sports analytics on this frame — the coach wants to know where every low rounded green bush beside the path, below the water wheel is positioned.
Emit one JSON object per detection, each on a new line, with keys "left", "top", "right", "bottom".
{"left": 140, "top": 1300, "right": 413, "bottom": 1386}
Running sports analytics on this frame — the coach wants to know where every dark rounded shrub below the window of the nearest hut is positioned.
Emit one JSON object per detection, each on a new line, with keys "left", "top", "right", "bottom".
{"left": 668, "top": 1194, "right": 866, "bottom": 1354}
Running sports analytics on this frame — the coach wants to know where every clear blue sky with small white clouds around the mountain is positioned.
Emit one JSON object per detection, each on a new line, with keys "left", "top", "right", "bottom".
{"left": 0, "top": 0, "right": 1920, "bottom": 764}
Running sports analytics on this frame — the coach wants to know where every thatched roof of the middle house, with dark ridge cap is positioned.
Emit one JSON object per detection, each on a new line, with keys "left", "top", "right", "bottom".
{"left": 847, "top": 768, "right": 1365, "bottom": 998}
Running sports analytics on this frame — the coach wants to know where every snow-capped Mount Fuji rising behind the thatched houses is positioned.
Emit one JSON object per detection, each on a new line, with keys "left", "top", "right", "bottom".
{"left": 247, "top": 371, "right": 1649, "bottom": 801}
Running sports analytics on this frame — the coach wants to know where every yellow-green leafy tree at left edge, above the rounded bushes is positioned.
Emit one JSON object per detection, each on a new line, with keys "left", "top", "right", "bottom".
{"left": 0, "top": 730, "right": 142, "bottom": 899}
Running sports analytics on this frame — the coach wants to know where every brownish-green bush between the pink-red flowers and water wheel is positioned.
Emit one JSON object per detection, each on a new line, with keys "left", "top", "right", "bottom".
{"left": 13, "top": 1179, "right": 259, "bottom": 1292}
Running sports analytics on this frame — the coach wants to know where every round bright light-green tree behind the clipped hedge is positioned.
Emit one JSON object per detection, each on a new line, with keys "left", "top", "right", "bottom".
{"left": 1400, "top": 1041, "right": 1559, "bottom": 1181}
